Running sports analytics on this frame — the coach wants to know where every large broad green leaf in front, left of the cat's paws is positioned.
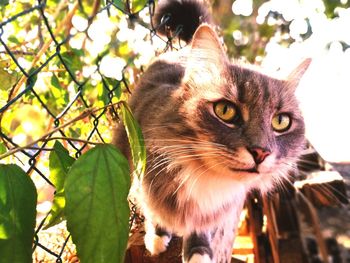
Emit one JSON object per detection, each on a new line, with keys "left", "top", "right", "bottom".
{"left": 65, "top": 144, "right": 130, "bottom": 263}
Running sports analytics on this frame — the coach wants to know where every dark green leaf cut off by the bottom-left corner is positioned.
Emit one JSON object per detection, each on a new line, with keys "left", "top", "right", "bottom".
{"left": 0, "top": 164, "right": 37, "bottom": 263}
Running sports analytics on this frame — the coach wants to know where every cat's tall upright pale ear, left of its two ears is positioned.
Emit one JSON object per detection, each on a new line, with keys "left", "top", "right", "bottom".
{"left": 185, "top": 24, "right": 228, "bottom": 85}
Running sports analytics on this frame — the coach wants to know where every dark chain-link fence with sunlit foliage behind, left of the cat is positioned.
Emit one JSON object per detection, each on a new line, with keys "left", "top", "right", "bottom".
{"left": 0, "top": 0, "right": 180, "bottom": 262}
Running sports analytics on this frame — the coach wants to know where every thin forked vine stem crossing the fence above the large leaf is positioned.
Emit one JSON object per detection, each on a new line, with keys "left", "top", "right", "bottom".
{"left": 0, "top": 101, "right": 123, "bottom": 160}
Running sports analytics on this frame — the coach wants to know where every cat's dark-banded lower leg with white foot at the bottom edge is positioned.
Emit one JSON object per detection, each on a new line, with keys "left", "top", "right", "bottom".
{"left": 183, "top": 232, "right": 213, "bottom": 263}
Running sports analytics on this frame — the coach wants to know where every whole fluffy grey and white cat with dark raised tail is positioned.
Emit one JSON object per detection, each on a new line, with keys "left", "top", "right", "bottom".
{"left": 113, "top": 0, "right": 310, "bottom": 263}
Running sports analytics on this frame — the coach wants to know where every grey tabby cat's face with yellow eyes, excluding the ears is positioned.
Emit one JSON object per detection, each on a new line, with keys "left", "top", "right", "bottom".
{"left": 175, "top": 65, "right": 304, "bottom": 191}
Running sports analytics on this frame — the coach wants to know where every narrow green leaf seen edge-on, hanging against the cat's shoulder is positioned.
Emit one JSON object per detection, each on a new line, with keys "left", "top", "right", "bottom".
{"left": 120, "top": 102, "right": 146, "bottom": 178}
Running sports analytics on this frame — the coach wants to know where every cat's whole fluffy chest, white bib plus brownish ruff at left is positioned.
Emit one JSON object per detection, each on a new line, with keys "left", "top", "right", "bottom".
{"left": 143, "top": 165, "right": 246, "bottom": 235}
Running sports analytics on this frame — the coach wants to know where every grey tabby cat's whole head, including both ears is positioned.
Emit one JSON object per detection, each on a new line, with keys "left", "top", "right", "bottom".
{"left": 146, "top": 25, "right": 310, "bottom": 192}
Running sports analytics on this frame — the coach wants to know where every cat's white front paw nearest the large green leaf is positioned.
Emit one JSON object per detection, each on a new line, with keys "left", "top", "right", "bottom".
{"left": 145, "top": 221, "right": 172, "bottom": 255}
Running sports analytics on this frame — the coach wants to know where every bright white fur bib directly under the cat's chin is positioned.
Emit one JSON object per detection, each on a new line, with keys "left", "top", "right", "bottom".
{"left": 171, "top": 168, "right": 246, "bottom": 231}
